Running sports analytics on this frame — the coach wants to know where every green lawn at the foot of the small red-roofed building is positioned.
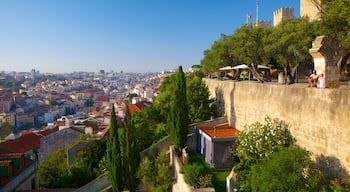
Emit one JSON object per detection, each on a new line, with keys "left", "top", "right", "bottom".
{"left": 189, "top": 153, "right": 231, "bottom": 191}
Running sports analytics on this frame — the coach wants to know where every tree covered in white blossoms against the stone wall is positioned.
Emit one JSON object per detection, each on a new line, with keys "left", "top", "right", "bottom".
{"left": 234, "top": 117, "right": 294, "bottom": 191}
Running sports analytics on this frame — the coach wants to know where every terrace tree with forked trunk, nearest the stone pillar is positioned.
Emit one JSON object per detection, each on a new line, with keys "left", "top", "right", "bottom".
{"left": 265, "top": 18, "right": 317, "bottom": 84}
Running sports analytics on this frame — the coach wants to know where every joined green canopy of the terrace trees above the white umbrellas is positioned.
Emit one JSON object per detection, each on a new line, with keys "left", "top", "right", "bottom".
{"left": 201, "top": 18, "right": 319, "bottom": 83}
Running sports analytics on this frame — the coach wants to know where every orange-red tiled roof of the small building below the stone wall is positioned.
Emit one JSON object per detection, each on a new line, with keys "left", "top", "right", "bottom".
{"left": 199, "top": 124, "right": 239, "bottom": 138}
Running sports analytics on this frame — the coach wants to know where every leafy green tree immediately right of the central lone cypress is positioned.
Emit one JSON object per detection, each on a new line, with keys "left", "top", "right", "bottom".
{"left": 186, "top": 76, "right": 212, "bottom": 123}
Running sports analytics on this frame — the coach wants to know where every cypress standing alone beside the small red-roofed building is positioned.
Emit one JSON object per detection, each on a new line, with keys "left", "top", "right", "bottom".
{"left": 167, "top": 66, "right": 188, "bottom": 151}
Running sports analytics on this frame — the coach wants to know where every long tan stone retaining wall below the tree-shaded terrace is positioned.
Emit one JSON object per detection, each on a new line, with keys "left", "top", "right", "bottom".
{"left": 205, "top": 79, "right": 350, "bottom": 172}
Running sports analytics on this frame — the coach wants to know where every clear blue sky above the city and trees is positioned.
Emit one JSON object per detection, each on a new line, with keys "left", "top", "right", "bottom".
{"left": 0, "top": 0, "right": 300, "bottom": 73}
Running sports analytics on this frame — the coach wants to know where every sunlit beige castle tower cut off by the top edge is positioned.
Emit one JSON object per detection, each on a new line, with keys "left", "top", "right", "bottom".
{"left": 300, "top": 0, "right": 322, "bottom": 21}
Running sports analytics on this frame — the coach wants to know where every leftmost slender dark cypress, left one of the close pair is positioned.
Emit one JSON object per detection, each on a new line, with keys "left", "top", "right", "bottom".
{"left": 106, "top": 105, "right": 123, "bottom": 192}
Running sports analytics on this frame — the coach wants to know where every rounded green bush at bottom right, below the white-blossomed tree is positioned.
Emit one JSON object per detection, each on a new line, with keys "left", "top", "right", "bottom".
{"left": 249, "top": 147, "right": 321, "bottom": 192}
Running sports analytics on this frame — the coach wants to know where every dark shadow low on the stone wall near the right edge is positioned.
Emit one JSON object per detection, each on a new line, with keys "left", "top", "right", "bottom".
{"left": 316, "top": 155, "right": 349, "bottom": 178}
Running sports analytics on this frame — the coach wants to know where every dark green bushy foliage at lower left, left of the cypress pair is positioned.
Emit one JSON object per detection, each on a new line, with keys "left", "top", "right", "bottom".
{"left": 39, "top": 137, "right": 106, "bottom": 188}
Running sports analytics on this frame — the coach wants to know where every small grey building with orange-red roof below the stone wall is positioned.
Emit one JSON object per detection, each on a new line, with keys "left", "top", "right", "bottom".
{"left": 196, "top": 123, "right": 239, "bottom": 168}
